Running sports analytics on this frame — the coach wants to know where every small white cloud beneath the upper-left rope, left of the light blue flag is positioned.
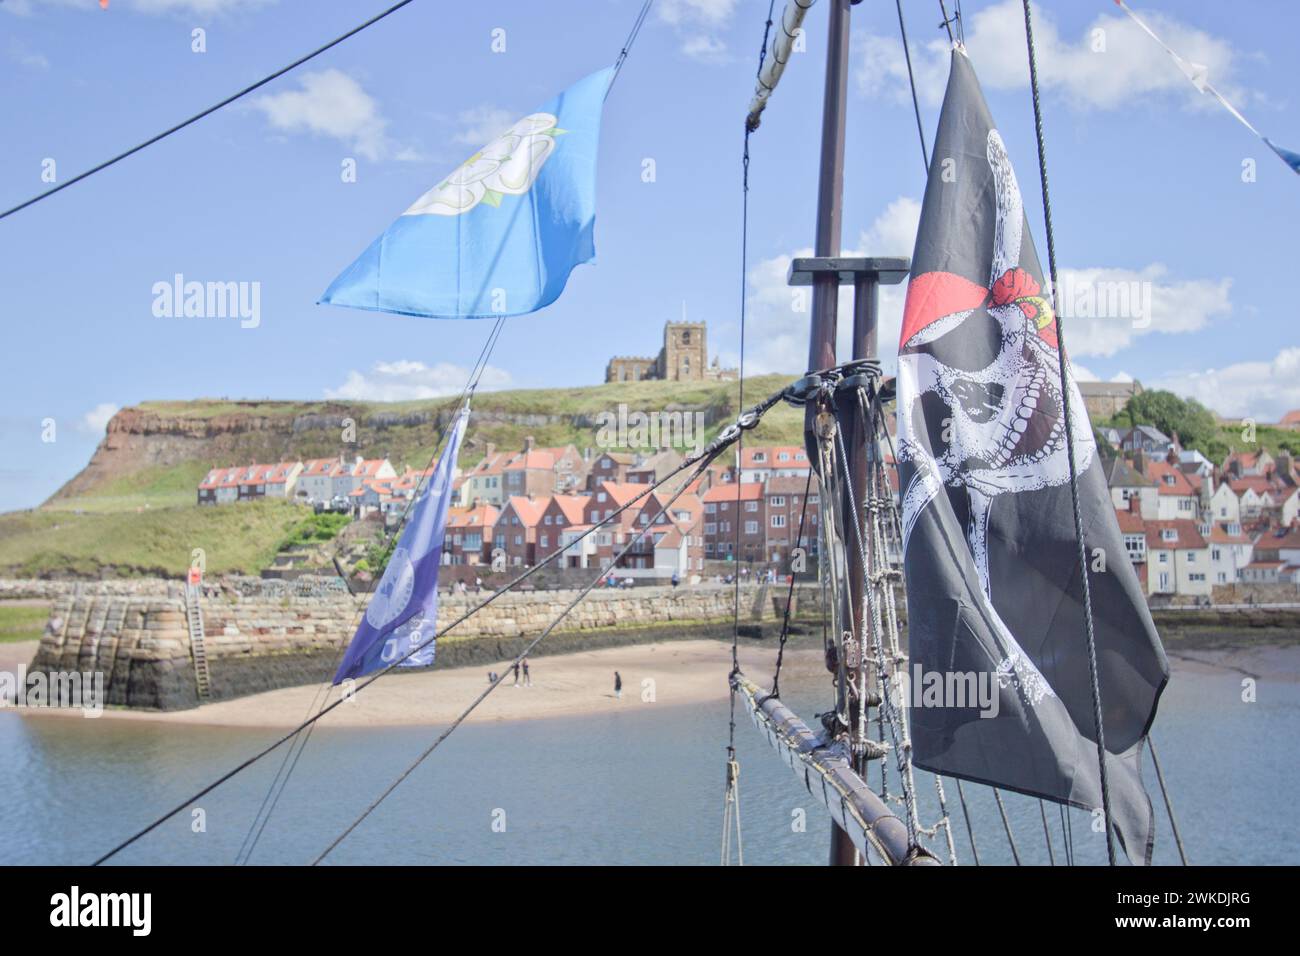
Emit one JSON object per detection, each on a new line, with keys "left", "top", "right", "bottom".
{"left": 251, "top": 68, "right": 413, "bottom": 160}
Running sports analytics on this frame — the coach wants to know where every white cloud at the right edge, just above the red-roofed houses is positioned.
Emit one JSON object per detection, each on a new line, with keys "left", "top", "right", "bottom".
{"left": 1147, "top": 347, "right": 1300, "bottom": 423}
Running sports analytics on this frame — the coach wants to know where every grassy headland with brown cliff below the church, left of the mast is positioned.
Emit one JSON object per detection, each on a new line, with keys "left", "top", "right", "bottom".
{"left": 0, "top": 376, "right": 803, "bottom": 578}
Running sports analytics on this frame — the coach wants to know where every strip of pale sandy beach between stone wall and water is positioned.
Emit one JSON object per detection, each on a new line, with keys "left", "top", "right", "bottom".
{"left": 0, "top": 639, "right": 1300, "bottom": 730}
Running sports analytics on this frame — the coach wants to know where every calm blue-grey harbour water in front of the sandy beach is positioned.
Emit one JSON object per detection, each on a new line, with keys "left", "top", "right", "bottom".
{"left": 0, "top": 660, "right": 1300, "bottom": 865}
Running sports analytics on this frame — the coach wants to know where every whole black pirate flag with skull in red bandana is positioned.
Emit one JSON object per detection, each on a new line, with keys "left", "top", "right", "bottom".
{"left": 898, "top": 49, "right": 1169, "bottom": 864}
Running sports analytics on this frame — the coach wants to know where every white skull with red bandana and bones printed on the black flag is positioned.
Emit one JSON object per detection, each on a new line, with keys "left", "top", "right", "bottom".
{"left": 898, "top": 129, "right": 1095, "bottom": 704}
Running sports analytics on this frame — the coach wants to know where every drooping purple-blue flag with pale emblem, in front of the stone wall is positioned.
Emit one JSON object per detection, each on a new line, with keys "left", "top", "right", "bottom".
{"left": 334, "top": 406, "right": 469, "bottom": 684}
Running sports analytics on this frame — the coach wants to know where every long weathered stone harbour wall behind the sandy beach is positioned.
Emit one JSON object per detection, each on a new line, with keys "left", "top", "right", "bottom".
{"left": 31, "top": 585, "right": 820, "bottom": 710}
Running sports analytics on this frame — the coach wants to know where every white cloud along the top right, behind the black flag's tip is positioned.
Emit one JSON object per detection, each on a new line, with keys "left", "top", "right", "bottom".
{"left": 855, "top": 0, "right": 1247, "bottom": 109}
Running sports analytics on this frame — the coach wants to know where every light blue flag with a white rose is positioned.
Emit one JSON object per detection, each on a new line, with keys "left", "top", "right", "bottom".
{"left": 320, "top": 69, "right": 612, "bottom": 319}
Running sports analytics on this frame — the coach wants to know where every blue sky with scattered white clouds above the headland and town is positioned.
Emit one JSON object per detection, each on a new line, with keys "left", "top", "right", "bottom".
{"left": 0, "top": 0, "right": 1300, "bottom": 510}
